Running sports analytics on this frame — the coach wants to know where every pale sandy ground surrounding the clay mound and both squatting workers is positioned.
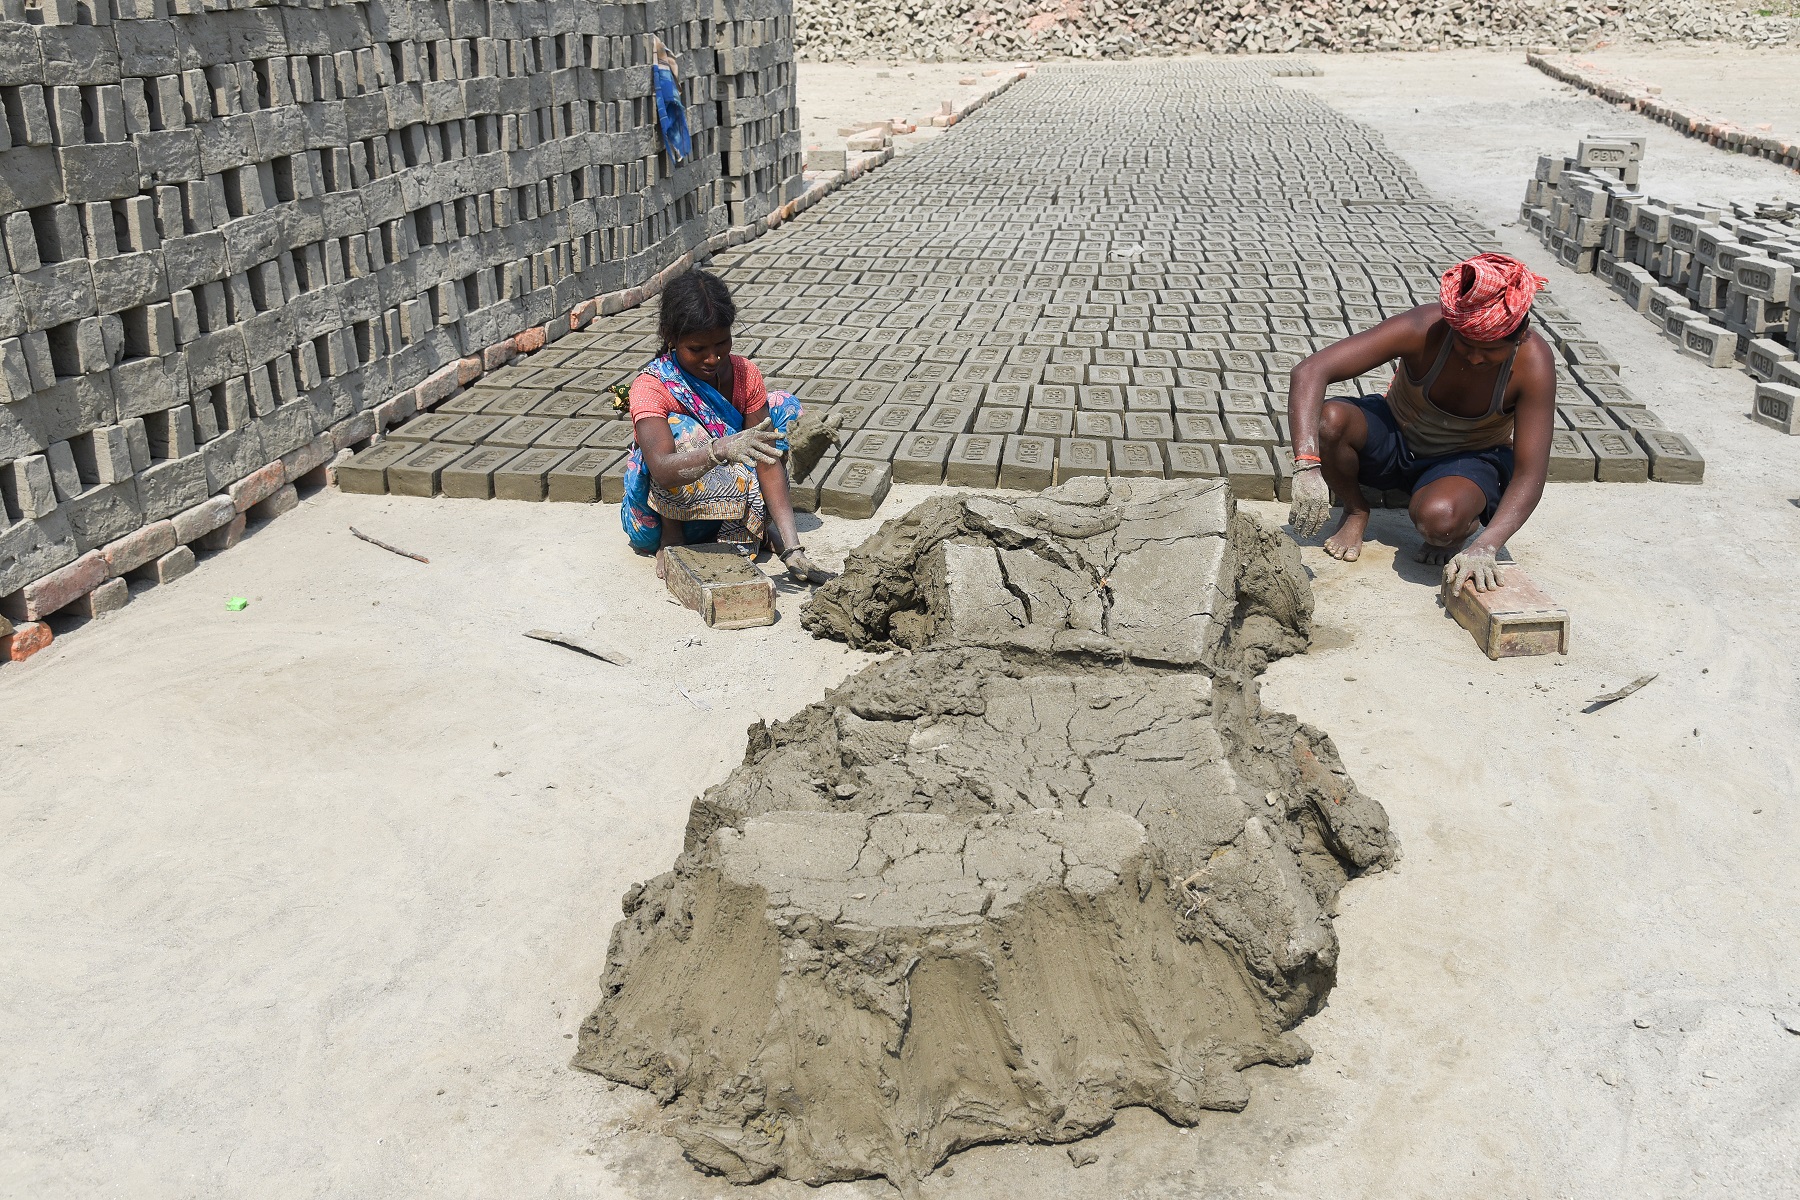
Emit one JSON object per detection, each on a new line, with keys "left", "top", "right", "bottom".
{"left": 0, "top": 52, "right": 1800, "bottom": 1200}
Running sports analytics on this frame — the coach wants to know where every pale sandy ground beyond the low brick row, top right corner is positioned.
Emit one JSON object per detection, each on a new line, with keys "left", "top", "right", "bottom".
{"left": 1577, "top": 45, "right": 1800, "bottom": 146}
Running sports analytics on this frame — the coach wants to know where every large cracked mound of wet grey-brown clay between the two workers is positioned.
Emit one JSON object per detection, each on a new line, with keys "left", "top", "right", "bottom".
{"left": 574, "top": 479, "right": 1399, "bottom": 1186}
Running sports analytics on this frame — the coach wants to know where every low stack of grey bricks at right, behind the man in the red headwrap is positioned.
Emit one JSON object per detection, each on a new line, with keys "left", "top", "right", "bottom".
{"left": 1521, "top": 137, "right": 1800, "bottom": 434}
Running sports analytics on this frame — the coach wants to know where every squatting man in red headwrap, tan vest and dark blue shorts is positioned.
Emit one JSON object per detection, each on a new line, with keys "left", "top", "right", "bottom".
{"left": 1287, "top": 254, "right": 1557, "bottom": 592}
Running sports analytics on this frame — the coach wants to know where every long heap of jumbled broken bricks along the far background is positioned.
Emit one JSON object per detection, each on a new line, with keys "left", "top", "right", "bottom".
{"left": 794, "top": 0, "right": 1796, "bottom": 61}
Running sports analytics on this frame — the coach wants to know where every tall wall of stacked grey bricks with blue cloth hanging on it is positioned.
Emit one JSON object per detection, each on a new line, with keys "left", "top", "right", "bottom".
{"left": 0, "top": 0, "right": 801, "bottom": 633}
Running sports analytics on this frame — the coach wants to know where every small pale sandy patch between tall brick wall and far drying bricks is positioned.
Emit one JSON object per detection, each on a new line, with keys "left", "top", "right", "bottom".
{"left": 796, "top": 59, "right": 1006, "bottom": 153}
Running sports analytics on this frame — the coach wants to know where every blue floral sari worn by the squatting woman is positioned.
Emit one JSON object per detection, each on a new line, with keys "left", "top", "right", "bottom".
{"left": 619, "top": 353, "right": 801, "bottom": 554}
